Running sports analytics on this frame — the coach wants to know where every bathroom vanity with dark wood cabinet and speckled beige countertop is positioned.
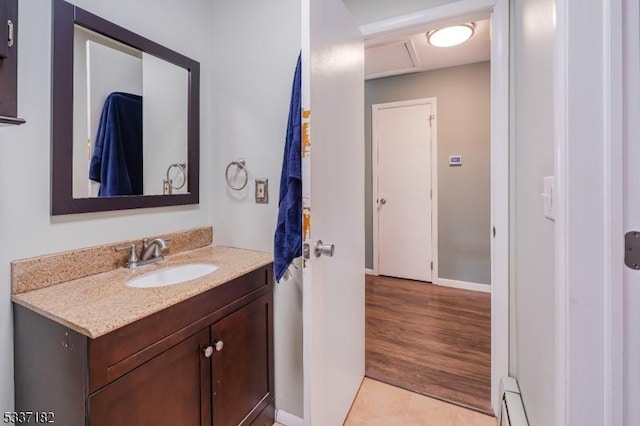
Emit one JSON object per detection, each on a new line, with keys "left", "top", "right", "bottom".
{"left": 13, "top": 233, "right": 274, "bottom": 426}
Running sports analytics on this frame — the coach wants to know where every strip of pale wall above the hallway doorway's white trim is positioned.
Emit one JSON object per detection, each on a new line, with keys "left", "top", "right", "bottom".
{"left": 343, "top": 0, "right": 458, "bottom": 25}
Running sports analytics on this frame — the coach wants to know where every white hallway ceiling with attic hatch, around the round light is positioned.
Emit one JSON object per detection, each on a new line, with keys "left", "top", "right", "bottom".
{"left": 365, "top": 19, "right": 491, "bottom": 80}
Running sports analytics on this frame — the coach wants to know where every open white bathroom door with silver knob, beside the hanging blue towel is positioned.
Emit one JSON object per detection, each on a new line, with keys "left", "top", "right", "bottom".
{"left": 302, "top": 0, "right": 364, "bottom": 426}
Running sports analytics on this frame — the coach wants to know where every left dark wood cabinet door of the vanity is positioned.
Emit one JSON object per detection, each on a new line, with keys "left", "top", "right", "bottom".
{"left": 88, "top": 328, "right": 211, "bottom": 426}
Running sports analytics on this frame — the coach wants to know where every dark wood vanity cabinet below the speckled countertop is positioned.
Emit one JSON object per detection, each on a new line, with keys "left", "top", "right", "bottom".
{"left": 14, "top": 265, "right": 275, "bottom": 426}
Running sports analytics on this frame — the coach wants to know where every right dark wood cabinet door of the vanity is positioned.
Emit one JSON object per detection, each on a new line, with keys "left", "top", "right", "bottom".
{"left": 211, "top": 293, "right": 273, "bottom": 426}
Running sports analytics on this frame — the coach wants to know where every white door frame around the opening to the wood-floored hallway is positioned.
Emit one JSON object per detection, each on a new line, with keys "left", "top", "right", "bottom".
{"left": 360, "top": 0, "right": 511, "bottom": 414}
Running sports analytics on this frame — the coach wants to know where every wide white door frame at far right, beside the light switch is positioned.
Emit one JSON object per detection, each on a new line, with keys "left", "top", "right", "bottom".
{"left": 553, "top": 0, "right": 624, "bottom": 426}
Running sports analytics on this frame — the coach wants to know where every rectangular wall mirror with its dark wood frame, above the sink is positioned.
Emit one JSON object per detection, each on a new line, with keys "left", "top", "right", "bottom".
{"left": 51, "top": 0, "right": 199, "bottom": 215}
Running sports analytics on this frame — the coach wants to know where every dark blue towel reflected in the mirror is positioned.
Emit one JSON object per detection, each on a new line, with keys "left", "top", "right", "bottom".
{"left": 89, "top": 92, "right": 143, "bottom": 197}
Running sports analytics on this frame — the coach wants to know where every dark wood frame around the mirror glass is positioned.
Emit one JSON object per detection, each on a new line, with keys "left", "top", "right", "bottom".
{"left": 51, "top": 0, "right": 200, "bottom": 216}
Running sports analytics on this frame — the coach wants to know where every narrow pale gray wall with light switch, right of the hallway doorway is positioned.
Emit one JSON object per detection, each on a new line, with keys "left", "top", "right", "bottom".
{"left": 509, "top": 0, "right": 556, "bottom": 425}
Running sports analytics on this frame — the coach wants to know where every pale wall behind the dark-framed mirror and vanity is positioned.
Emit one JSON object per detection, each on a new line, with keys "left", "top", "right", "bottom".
{"left": 0, "top": 0, "right": 217, "bottom": 411}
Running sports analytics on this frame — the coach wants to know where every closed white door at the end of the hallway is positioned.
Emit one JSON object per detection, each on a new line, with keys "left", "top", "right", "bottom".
{"left": 373, "top": 100, "right": 433, "bottom": 281}
